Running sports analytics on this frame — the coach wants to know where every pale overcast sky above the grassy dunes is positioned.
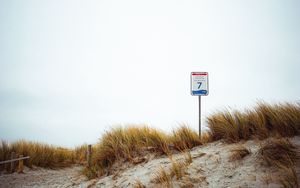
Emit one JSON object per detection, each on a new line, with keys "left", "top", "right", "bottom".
{"left": 0, "top": 0, "right": 300, "bottom": 147}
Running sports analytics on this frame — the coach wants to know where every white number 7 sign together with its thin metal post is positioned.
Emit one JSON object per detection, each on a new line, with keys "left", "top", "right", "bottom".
{"left": 191, "top": 72, "right": 208, "bottom": 139}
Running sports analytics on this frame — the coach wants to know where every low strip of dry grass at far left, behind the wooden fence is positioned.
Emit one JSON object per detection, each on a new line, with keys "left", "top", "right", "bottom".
{"left": 0, "top": 140, "right": 74, "bottom": 168}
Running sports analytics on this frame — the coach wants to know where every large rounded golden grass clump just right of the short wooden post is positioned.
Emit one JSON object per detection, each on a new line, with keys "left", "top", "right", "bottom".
{"left": 93, "top": 126, "right": 169, "bottom": 175}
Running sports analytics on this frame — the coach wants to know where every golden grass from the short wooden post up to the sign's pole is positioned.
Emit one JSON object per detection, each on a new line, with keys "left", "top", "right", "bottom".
{"left": 89, "top": 125, "right": 201, "bottom": 176}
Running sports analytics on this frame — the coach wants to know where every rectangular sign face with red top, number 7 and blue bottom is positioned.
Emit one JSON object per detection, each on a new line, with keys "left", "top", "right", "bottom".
{"left": 191, "top": 72, "right": 208, "bottom": 95}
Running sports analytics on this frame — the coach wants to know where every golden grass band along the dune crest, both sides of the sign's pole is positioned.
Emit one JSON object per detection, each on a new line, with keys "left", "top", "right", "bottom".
{"left": 86, "top": 102, "right": 300, "bottom": 178}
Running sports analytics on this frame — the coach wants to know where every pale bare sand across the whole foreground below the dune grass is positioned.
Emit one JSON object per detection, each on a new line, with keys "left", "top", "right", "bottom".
{"left": 0, "top": 137, "right": 300, "bottom": 187}
